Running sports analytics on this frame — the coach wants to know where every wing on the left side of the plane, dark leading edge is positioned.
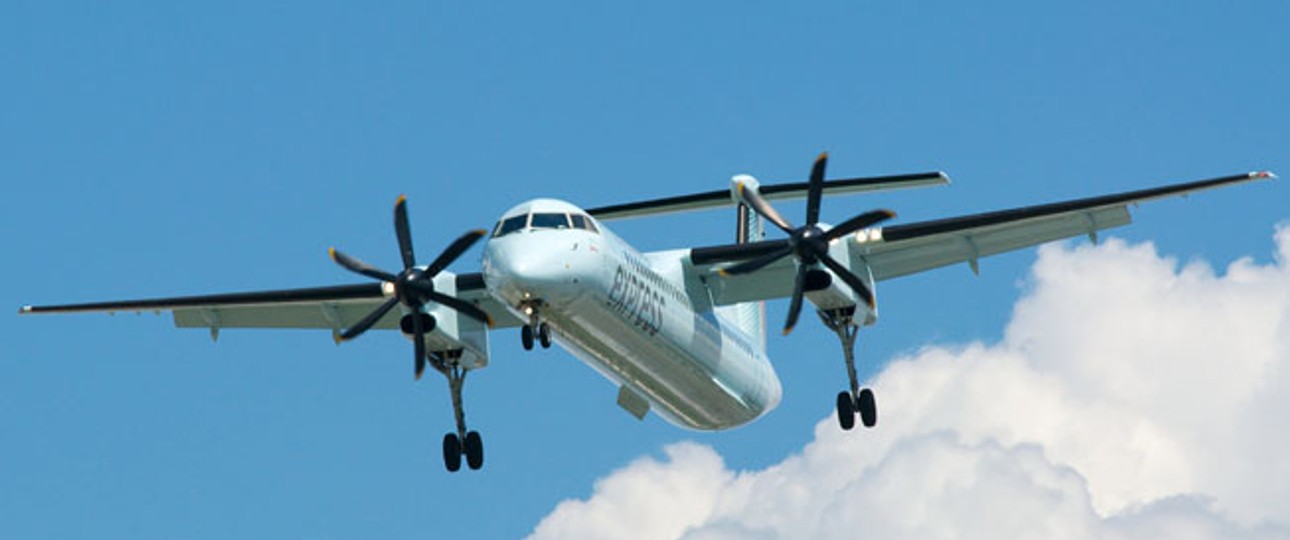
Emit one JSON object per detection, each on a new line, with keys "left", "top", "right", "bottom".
{"left": 18, "top": 273, "right": 520, "bottom": 333}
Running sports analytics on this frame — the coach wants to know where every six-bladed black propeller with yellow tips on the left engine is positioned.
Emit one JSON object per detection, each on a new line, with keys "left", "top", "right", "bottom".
{"left": 328, "top": 195, "right": 493, "bottom": 379}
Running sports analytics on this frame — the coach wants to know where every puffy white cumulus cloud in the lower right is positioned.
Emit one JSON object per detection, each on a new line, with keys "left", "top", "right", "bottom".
{"left": 533, "top": 227, "right": 1290, "bottom": 539}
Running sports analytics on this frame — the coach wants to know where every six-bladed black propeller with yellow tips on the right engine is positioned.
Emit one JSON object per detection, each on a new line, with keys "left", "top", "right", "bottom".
{"left": 717, "top": 152, "right": 895, "bottom": 335}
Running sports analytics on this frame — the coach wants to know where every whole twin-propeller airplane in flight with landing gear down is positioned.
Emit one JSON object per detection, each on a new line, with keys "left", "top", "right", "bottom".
{"left": 19, "top": 153, "right": 1276, "bottom": 472}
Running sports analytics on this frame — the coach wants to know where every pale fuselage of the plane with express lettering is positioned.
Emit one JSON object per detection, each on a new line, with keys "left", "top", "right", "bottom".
{"left": 484, "top": 200, "right": 782, "bottom": 430}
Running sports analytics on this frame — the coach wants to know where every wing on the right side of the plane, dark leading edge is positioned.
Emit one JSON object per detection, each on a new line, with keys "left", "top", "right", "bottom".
{"left": 690, "top": 168, "right": 1276, "bottom": 304}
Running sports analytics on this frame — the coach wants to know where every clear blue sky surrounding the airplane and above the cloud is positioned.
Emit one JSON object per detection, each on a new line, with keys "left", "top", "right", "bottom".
{"left": 0, "top": 1, "right": 1290, "bottom": 537}
